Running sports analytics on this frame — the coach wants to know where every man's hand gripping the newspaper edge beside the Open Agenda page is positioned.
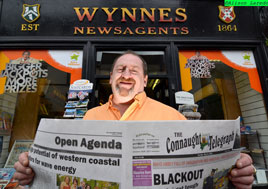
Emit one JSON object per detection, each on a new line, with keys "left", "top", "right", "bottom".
{"left": 14, "top": 152, "right": 34, "bottom": 185}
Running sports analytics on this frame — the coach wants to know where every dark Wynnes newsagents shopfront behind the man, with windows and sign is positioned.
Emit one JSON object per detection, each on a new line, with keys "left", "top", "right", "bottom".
{"left": 0, "top": 0, "right": 268, "bottom": 171}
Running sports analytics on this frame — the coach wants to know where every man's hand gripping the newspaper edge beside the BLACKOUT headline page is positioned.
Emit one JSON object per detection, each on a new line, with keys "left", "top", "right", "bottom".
{"left": 229, "top": 153, "right": 255, "bottom": 189}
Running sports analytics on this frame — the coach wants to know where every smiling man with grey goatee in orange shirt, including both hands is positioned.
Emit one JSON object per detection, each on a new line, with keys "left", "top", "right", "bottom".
{"left": 14, "top": 51, "right": 255, "bottom": 189}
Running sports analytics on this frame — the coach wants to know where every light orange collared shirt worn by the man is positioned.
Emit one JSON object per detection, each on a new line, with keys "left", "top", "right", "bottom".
{"left": 84, "top": 92, "right": 186, "bottom": 121}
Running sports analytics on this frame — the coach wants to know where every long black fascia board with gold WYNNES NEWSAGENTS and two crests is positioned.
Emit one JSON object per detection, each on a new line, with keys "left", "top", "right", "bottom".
{"left": 0, "top": 0, "right": 259, "bottom": 38}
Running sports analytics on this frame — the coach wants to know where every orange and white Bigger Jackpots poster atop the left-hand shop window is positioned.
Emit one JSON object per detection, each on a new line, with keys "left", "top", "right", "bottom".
{"left": 0, "top": 50, "right": 83, "bottom": 91}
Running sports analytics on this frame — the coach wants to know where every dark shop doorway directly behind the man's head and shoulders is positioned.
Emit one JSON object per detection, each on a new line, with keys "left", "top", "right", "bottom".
{"left": 94, "top": 51, "right": 171, "bottom": 106}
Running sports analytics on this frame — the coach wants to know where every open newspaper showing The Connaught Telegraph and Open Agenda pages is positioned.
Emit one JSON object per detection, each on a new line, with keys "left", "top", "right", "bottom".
{"left": 29, "top": 119, "right": 240, "bottom": 189}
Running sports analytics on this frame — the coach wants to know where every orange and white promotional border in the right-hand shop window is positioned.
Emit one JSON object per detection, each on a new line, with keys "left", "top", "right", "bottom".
{"left": 179, "top": 50, "right": 263, "bottom": 93}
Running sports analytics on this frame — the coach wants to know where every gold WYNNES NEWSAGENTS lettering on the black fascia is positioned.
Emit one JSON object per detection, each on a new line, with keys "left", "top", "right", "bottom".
{"left": 73, "top": 7, "right": 189, "bottom": 35}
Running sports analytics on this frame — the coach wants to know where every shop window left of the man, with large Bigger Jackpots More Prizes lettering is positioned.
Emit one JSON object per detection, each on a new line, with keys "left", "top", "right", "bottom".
{"left": 0, "top": 50, "right": 83, "bottom": 159}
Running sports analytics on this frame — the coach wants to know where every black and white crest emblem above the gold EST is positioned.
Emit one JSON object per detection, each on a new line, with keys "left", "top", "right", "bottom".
{"left": 21, "top": 4, "right": 40, "bottom": 23}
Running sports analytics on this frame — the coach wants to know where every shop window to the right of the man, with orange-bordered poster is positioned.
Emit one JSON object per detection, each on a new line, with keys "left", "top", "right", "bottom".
{"left": 179, "top": 51, "right": 267, "bottom": 121}
